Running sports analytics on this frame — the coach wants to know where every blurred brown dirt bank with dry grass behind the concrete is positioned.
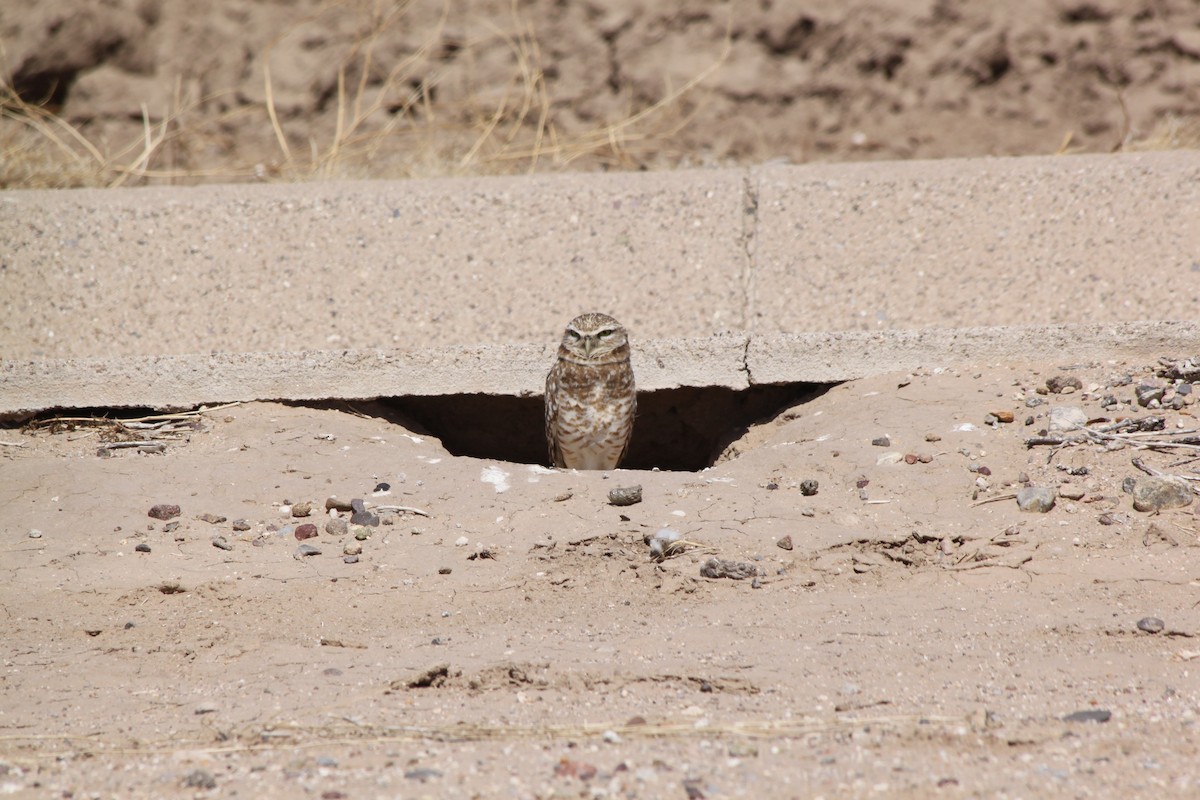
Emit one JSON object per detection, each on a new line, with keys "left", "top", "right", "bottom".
{"left": 0, "top": 0, "right": 1200, "bottom": 186}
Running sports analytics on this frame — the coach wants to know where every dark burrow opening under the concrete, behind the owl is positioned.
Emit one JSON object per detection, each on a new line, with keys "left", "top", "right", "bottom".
{"left": 376, "top": 384, "right": 835, "bottom": 471}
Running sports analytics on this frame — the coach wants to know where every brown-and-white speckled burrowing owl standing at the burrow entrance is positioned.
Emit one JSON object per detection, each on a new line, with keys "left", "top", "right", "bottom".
{"left": 546, "top": 313, "right": 637, "bottom": 469}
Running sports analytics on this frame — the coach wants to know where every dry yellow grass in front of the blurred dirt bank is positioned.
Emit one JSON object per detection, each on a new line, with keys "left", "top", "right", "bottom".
{"left": 0, "top": 0, "right": 730, "bottom": 188}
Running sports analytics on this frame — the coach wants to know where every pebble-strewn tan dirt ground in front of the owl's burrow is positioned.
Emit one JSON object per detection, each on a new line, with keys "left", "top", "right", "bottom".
{"left": 0, "top": 362, "right": 1200, "bottom": 799}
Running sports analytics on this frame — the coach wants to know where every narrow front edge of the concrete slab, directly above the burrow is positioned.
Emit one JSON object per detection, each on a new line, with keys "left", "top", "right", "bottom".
{"left": 0, "top": 321, "right": 1200, "bottom": 419}
